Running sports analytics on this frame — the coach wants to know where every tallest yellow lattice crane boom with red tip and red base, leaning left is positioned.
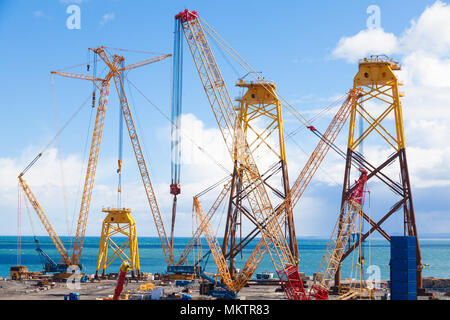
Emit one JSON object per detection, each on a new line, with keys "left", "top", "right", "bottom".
{"left": 176, "top": 10, "right": 306, "bottom": 299}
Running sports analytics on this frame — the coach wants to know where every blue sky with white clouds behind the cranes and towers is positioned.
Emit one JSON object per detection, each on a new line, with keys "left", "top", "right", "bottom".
{"left": 0, "top": 0, "right": 450, "bottom": 242}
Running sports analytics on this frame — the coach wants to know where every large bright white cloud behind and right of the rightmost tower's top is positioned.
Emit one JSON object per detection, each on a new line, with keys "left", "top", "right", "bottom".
{"left": 333, "top": 1, "right": 450, "bottom": 188}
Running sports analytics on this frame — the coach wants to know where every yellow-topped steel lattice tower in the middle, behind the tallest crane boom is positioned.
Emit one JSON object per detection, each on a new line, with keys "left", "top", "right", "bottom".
{"left": 222, "top": 79, "right": 298, "bottom": 277}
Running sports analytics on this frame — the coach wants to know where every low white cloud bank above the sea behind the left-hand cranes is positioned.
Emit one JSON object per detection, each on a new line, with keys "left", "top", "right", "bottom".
{"left": 0, "top": 114, "right": 236, "bottom": 236}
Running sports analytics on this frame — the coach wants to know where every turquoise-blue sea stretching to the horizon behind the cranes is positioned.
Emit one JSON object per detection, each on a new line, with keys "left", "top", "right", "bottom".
{"left": 0, "top": 236, "right": 450, "bottom": 279}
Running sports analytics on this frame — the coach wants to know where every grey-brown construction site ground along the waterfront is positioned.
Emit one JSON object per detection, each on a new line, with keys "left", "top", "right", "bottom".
{"left": 0, "top": 279, "right": 450, "bottom": 300}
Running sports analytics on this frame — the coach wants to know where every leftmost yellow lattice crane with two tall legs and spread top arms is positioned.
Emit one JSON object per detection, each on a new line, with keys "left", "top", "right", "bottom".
{"left": 19, "top": 46, "right": 173, "bottom": 272}
